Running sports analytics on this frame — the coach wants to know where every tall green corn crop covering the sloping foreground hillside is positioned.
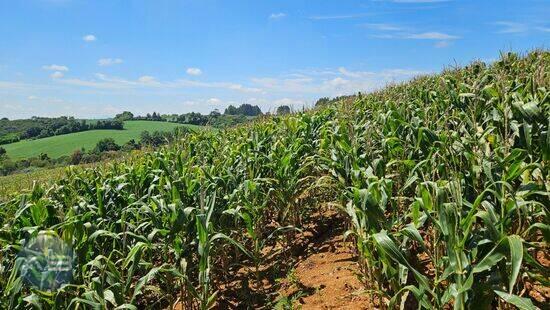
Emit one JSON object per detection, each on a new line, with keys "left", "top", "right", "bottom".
{"left": 0, "top": 51, "right": 550, "bottom": 309}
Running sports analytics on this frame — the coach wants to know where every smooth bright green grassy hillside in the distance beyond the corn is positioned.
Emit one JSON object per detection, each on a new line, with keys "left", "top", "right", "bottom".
{"left": 2, "top": 121, "right": 200, "bottom": 160}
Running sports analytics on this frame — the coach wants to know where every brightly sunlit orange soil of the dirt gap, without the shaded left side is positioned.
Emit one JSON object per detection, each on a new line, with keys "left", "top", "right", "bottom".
{"left": 280, "top": 225, "right": 374, "bottom": 310}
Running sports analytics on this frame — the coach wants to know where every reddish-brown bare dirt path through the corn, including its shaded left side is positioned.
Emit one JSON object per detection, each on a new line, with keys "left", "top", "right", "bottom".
{"left": 174, "top": 210, "right": 375, "bottom": 310}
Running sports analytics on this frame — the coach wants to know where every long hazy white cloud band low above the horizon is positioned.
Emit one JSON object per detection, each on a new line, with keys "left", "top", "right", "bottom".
{"left": 4, "top": 63, "right": 437, "bottom": 117}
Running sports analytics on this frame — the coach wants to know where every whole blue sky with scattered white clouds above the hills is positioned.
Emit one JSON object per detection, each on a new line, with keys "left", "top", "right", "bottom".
{"left": 0, "top": 0, "right": 550, "bottom": 118}
